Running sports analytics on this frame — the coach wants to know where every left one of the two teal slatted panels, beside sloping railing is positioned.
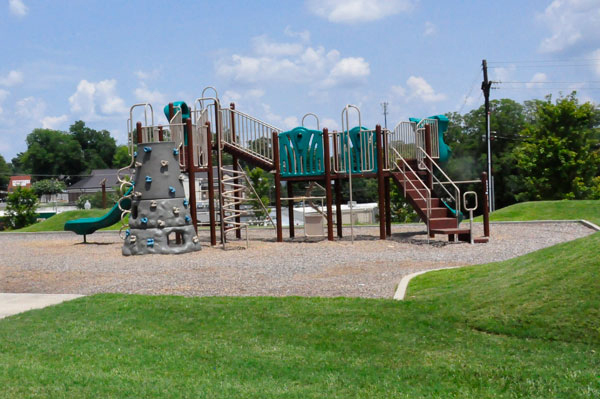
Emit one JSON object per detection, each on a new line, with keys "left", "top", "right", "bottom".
{"left": 279, "top": 127, "right": 325, "bottom": 177}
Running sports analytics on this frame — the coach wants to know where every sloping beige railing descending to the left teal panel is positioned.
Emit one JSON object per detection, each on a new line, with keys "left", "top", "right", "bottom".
{"left": 221, "top": 109, "right": 282, "bottom": 162}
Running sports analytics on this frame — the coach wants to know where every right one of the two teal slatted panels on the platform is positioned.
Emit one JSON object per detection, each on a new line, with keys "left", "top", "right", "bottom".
{"left": 337, "top": 126, "right": 377, "bottom": 173}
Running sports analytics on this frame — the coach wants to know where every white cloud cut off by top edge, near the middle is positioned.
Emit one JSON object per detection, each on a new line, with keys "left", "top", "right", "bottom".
{"left": 306, "top": 0, "right": 415, "bottom": 23}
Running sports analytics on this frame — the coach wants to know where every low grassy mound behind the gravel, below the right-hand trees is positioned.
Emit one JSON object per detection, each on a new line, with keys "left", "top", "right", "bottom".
{"left": 475, "top": 200, "right": 600, "bottom": 225}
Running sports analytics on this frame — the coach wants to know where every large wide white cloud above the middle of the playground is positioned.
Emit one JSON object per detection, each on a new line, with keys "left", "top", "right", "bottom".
{"left": 215, "top": 36, "right": 370, "bottom": 88}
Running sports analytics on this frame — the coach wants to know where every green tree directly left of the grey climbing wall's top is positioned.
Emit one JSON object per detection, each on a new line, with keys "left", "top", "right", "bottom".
{"left": 69, "top": 121, "right": 117, "bottom": 170}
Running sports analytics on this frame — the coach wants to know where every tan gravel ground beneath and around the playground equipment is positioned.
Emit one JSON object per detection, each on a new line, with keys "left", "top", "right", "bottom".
{"left": 0, "top": 223, "right": 593, "bottom": 298}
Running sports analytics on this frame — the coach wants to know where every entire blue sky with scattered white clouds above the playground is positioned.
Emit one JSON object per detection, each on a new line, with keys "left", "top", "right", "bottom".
{"left": 0, "top": 0, "right": 600, "bottom": 161}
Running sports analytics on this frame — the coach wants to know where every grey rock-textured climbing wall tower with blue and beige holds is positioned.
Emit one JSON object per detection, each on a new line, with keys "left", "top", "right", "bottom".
{"left": 123, "top": 142, "right": 200, "bottom": 255}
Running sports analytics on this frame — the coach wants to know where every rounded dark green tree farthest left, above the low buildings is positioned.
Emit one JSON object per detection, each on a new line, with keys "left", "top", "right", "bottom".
{"left": 19, "top": 129, "right": 85, "bottom": 176}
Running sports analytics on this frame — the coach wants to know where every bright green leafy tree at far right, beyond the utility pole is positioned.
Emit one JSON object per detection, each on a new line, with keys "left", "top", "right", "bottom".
{"left": 516, "top": 92, "right": 600, "bottom": 201}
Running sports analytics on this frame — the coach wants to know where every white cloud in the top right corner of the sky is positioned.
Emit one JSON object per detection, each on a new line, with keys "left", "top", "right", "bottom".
{"left": 538, "top": 0, "right": 600, "bottom": 53}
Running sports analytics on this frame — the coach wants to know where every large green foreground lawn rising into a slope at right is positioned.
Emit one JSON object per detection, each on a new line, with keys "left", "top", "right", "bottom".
{"left": 0, "top": 233, "right": 600, "bottom": 399}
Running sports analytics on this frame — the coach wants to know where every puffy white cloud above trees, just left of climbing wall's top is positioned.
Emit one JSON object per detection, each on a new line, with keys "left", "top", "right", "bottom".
{"left": 69, "top": 79, "right": 127, "bottom": 120}
